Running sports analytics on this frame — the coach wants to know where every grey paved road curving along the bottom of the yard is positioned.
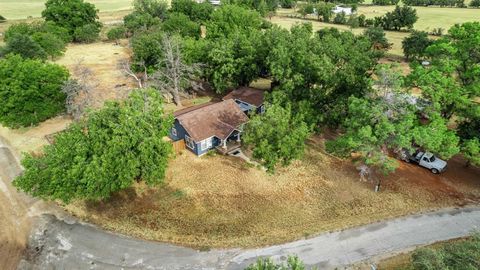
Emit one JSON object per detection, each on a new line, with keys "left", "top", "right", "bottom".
{"left": 0, "top": 138, "right": 480, "bottom": 270}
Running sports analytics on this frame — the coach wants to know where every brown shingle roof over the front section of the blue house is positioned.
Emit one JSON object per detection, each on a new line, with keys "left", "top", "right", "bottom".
{"left": 173, "top": 99, "right": 248, "bottom": 142}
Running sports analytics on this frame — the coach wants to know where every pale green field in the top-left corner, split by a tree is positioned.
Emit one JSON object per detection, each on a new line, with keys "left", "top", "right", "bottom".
{"left": 0, "top": 0, "right": 133, "bottom": 20}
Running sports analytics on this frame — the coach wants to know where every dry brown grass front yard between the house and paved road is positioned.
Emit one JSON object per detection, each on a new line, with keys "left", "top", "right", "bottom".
{"left": 66, "top": 138, "right": 479, "bottom": 247}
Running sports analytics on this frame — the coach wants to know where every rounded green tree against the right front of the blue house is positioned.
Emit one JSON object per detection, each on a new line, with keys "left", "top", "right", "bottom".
{"left": 243, "top": 101, "right": 309, "bottom": 172}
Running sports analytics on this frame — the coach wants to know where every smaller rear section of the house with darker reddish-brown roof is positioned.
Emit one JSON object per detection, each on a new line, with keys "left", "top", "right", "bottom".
{"left": 223, "top": 87, "right": 265, "bottom": 114}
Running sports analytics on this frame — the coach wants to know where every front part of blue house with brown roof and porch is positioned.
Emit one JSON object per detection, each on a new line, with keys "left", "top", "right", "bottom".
{"left": 169, "top": 99, "right": 248, "bottom": 156}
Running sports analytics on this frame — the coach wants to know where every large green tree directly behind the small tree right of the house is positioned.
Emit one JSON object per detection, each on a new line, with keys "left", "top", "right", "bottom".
{"left": 261, "top": 24, "right": 378, "bottom": 125}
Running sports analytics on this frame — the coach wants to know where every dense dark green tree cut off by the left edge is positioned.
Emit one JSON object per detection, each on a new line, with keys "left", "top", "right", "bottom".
{"left": 0, "top": 55, "right": 69, "bottom": 128}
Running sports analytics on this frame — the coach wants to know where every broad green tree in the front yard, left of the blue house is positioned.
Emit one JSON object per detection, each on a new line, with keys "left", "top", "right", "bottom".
{"left": 13, "top": 89, "right": 172, "bottom": 203}
